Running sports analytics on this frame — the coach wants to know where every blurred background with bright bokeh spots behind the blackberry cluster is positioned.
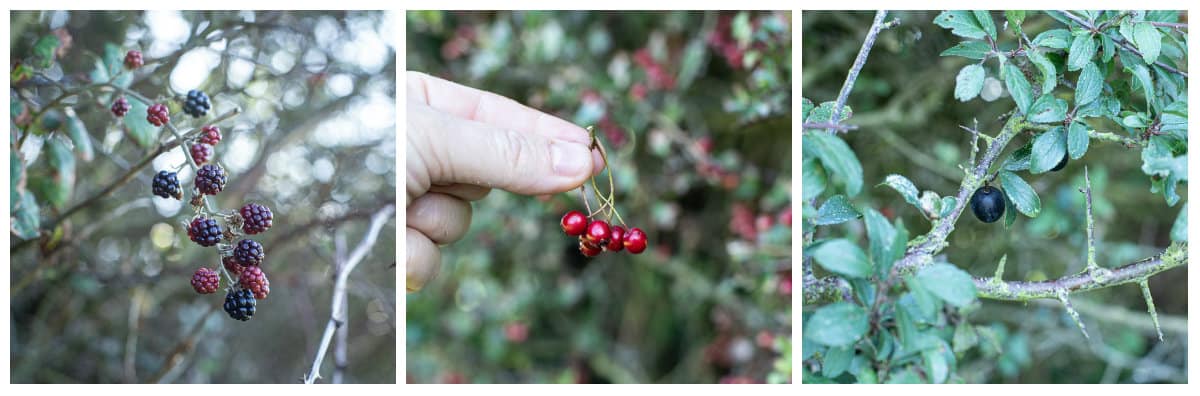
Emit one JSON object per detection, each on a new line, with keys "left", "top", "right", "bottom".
{"left": 10, "top": 11, "right": 396, "bottom": 383}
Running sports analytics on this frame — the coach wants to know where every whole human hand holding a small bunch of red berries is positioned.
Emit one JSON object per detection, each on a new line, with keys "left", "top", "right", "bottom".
{"left": 404, "top": 72, "right": 604, "bottom": 293}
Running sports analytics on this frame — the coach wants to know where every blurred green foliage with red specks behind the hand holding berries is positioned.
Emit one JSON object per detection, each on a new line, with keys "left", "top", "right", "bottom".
{"left": 406, "top": 11, "right": 792, "bottom": 383}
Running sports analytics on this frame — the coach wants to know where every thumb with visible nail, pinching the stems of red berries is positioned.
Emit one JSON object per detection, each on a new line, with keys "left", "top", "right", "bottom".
{"left": 406, "top": 101, "right": 594, "bottom": 194}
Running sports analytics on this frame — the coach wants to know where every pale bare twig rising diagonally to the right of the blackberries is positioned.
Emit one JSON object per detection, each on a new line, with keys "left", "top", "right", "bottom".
{"left": 304, "top": 205, "right": 396, "bottom": 384}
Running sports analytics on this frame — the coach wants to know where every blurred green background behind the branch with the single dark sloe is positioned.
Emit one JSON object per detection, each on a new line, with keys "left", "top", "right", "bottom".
{"left": 800, "top": 11, "right": 1188, "bottom": 383}
